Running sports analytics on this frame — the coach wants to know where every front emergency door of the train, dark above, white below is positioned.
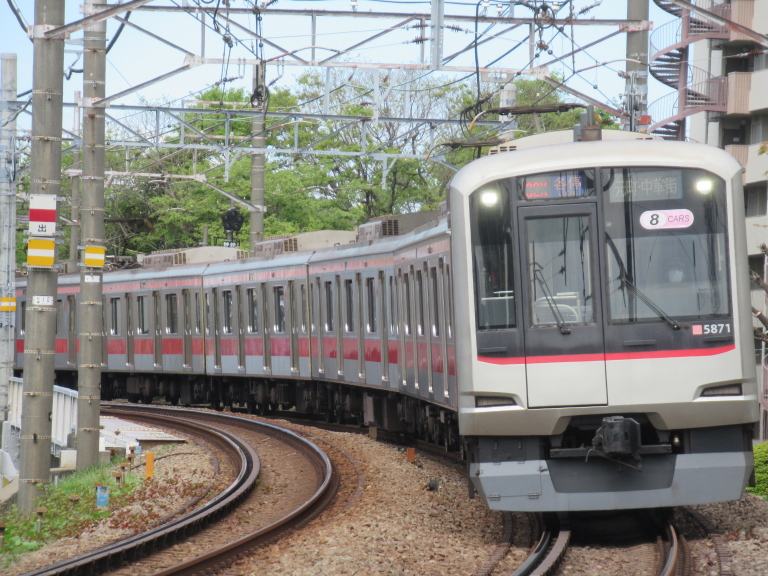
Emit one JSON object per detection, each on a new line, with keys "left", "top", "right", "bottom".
{"left": 518, "top": 203, "right": 608, "bottom": 408}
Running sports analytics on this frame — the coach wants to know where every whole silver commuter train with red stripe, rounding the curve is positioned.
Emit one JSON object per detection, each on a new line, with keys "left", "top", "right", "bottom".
{"left": 16, "top": 130, "right": 758, "bottom": 512}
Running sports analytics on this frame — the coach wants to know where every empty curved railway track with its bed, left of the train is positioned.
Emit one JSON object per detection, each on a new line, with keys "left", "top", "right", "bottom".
{"left": 18, "top": 405, "right": 338, "bottom": 576}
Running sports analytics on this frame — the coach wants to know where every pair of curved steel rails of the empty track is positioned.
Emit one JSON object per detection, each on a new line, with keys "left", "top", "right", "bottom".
{"left": 19, "top": 405, "right": 336, "bottom": 576}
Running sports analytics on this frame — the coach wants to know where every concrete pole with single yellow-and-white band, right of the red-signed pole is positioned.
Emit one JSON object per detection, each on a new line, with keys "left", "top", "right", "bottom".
{"left": 77, "top": 0, "right": 107, "bottom": 470}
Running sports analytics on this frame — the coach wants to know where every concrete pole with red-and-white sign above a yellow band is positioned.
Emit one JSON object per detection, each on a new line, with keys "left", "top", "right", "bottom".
{"left": 19, "top": 0, "right": 65, "bottom": 512}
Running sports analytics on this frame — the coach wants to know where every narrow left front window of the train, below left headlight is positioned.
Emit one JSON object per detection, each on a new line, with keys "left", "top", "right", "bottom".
{"left": 469, "top": 182, "right": 517, "bottom": 330}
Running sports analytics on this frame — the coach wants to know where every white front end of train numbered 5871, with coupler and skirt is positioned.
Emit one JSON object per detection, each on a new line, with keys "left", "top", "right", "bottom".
{"left": 450, "top": 136, "right": 758, "bottom": 511}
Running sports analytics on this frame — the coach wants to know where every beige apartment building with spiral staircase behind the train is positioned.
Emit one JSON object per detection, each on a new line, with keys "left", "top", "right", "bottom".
{"left": 649, "top": 0, "right": 768, "bottom": 438}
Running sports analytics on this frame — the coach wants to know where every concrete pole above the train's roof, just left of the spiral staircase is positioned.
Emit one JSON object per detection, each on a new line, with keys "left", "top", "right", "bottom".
{"left": 625, "top": 0, "right": 648, "bottom": 132}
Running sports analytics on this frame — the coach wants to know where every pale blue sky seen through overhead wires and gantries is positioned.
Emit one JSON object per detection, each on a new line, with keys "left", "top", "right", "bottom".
{"left": 0, "top": 0, "right": 673, "bottom": 135}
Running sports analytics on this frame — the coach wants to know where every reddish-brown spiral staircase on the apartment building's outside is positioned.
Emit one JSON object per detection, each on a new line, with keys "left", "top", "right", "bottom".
{"left": 648, "top": 0, "right": 730, "bottom": 140}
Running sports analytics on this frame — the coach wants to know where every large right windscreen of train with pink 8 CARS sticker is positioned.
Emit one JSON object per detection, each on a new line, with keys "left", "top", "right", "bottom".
{"left": 602, "top": 168, "right": 729, "bottom": 326}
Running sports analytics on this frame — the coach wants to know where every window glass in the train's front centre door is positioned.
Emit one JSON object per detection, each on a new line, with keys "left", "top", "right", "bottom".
{"left": 526, "top": 215, "right": 595, "bottom": 326}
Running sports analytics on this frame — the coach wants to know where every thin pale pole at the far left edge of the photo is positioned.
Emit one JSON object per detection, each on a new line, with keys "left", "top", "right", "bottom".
{"left": 0, "top": 54, "right": 17, "bottom": 424}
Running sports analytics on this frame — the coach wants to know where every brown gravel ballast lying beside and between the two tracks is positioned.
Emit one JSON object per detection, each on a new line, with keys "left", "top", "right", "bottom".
{"left": 3, "top": 427, "right": 768, "bottom": 576}
